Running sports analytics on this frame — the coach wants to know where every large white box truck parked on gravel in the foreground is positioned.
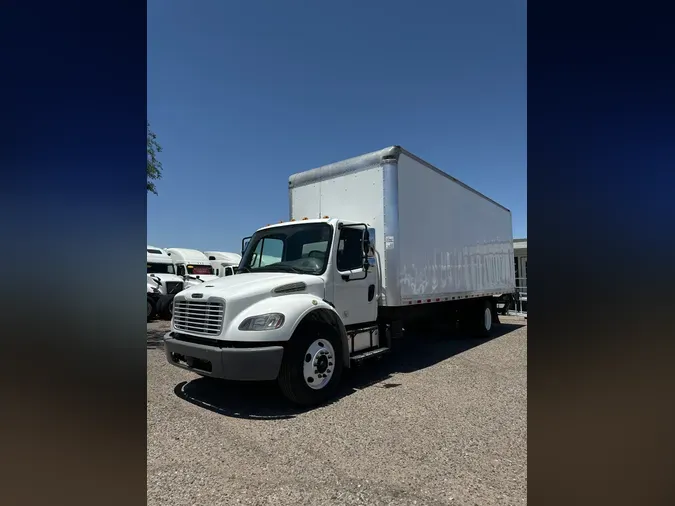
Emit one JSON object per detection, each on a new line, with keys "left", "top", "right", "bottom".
{"left": 165, "top": 146, "right": 515, "bottom": 405}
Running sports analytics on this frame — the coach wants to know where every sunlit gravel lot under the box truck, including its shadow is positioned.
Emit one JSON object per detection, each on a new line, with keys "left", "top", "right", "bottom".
{"left": 148, "top": 317, "right": 527, "bottom": 506}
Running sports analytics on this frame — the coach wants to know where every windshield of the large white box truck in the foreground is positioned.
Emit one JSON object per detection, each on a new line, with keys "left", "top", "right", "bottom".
{"left": 239, "top": 223, "right": 333, "bottom": 274}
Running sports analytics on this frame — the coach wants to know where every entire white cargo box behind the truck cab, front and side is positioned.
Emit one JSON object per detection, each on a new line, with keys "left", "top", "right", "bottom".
{"left": 289, "top": 146, "right": 515, "bottom": 306}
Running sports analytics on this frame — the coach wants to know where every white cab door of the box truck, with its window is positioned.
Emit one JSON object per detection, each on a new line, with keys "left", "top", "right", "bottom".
{"left": 332, "top": 224, "right": 378, "bottom": 325}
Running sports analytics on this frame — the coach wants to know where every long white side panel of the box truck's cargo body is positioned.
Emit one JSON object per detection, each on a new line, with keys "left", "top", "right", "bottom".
{"left": 396, "top": 150, "right": 515, "bottom": 305}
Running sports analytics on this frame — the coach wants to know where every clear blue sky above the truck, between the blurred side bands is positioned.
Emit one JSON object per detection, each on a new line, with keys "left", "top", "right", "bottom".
{"left": 147, "top": 0, "right": 527, "bottom": 252}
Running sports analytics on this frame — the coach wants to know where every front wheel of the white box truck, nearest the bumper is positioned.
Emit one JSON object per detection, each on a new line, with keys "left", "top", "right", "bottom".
{"left": 277, "top": 325, "right": 344, "bottom": 406}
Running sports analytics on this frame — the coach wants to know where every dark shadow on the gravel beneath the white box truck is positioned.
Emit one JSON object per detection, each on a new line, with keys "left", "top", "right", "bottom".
{"left": 174, "top": 323, "right": 524, "bottom": 420}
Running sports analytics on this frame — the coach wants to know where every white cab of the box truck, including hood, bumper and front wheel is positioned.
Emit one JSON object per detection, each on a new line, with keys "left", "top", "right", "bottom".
{"left": 165, "top": 218, "right": 374, "bottom": 404}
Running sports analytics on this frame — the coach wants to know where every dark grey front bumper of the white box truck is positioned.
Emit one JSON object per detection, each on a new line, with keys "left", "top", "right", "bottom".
{"left": 164, "top": 332, "right": 284, "bottom": 381}
